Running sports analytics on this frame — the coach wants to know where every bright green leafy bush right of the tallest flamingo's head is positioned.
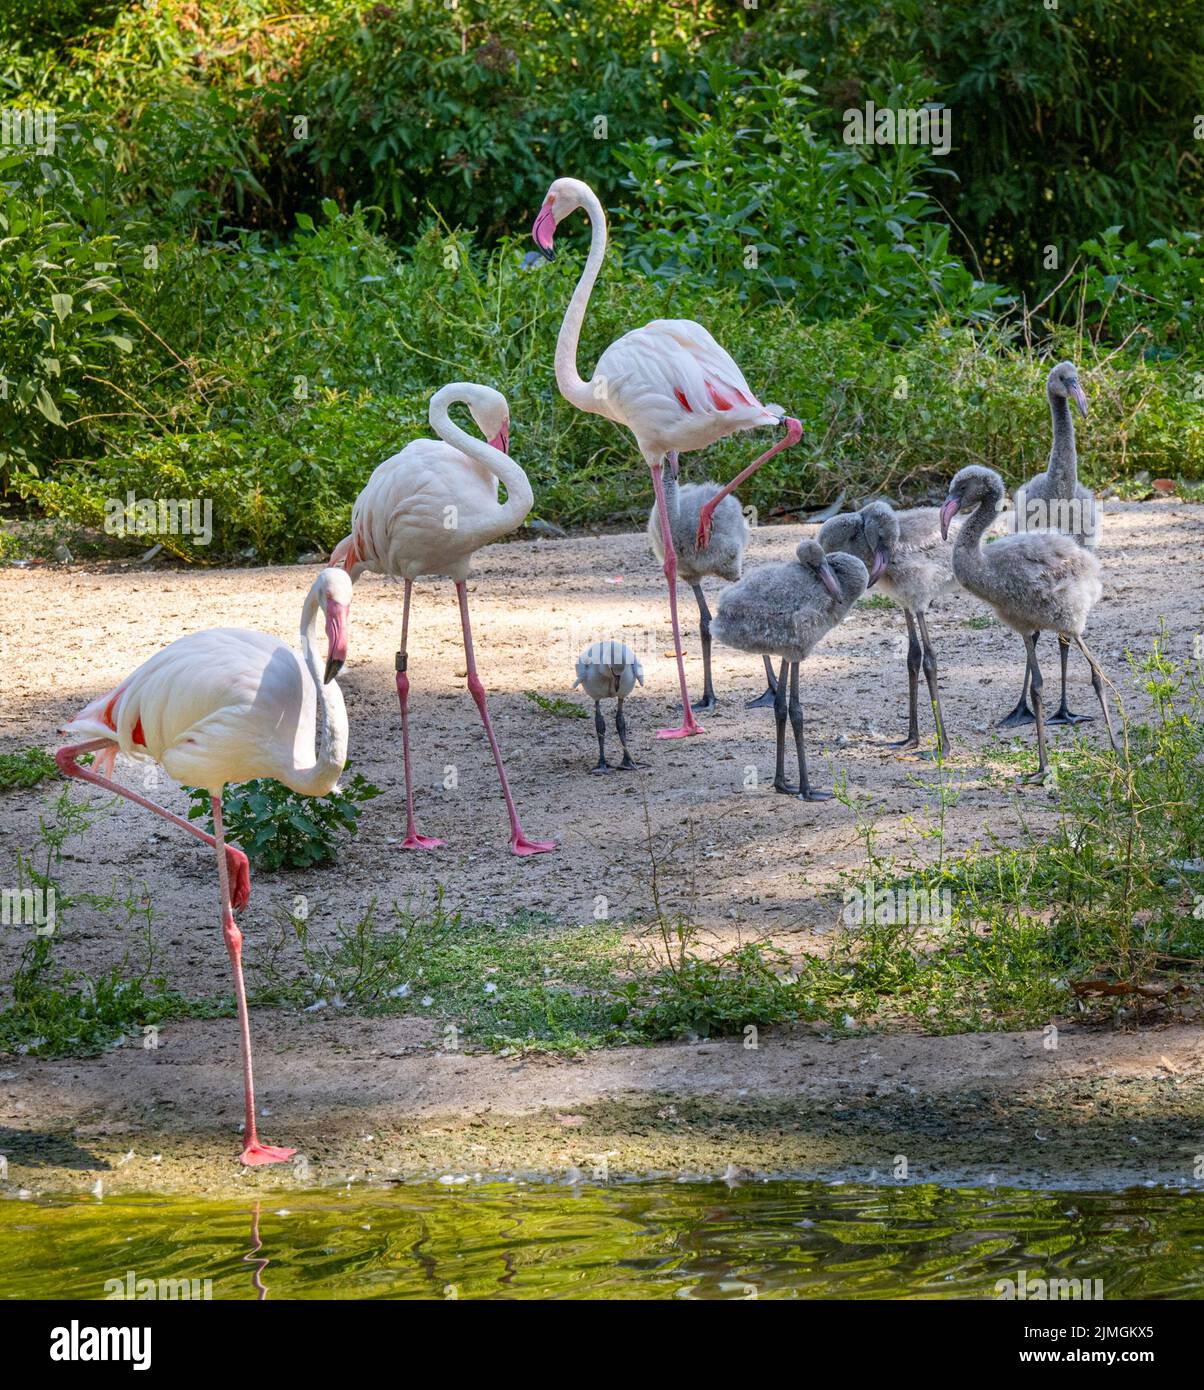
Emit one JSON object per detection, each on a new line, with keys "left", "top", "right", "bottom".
{"left": 608, "top": 64, "right": 1000, "bottom": 341}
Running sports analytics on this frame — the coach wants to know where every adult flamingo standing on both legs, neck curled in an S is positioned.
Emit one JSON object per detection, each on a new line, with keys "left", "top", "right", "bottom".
{"left": 331, "top": 381, "right": 556, "bottom": 855}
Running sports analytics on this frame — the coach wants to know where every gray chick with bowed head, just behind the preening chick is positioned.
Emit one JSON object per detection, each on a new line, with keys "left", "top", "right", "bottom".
{"left": 819, "top": 502, "right": 958, "bottom": 758}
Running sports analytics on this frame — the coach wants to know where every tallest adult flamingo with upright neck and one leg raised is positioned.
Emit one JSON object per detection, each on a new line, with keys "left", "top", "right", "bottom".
{"left": 531, "top": 178, "right": 802, "bottom": 738}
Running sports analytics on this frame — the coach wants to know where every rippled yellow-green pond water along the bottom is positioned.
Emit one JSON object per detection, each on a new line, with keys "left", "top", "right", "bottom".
{"left": 0, "top": 1182, "right": 1204, "bottom": 1300}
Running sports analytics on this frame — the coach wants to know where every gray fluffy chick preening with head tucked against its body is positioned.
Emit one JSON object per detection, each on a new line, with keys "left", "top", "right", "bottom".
{"left": 712, "top": 541, "right": 869, "bottom": 801}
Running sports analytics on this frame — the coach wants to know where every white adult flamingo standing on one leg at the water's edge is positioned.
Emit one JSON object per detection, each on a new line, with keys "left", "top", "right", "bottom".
{"left": 54, "top": 569, "right": 352, "bottom": 1165}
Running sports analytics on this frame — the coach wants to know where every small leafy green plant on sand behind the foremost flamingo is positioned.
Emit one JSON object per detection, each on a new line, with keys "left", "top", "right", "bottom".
{"left": 188, "top": 773, "right": 381, "bottom": 872}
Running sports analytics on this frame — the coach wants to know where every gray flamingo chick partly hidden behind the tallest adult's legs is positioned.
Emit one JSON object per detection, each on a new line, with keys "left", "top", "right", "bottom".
{"left": 648, "top": 453, "right": 773, "bottom": 713}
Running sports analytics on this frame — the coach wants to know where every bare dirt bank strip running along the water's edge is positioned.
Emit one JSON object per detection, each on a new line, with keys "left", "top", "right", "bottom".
{"left": 0, "top": 1013, "right": 1204, "bottom": 1193}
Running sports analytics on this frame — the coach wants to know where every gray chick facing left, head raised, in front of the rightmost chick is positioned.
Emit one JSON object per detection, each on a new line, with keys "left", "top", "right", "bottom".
{"left": 941, "top": 464, "right": 1116, "bottom": 783}
